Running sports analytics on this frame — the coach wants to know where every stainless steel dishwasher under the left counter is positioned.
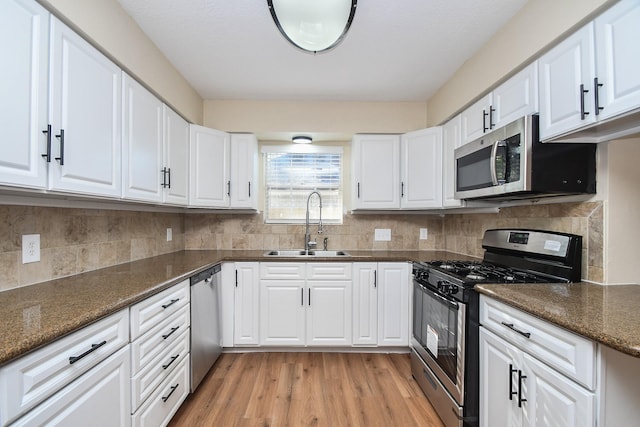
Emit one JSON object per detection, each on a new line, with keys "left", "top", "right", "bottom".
{"left": 191, "top": 264, "right": 222, "bottom": 393}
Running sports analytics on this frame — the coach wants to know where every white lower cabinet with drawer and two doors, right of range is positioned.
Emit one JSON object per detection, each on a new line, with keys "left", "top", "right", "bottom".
{"left": 480, "top": 296, "right": 597, "bottom": 427}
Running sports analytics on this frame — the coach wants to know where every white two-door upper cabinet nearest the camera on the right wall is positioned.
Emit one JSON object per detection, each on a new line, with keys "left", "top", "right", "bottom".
{"left": 539, "top": 0, "right": 640, "bottom": 142}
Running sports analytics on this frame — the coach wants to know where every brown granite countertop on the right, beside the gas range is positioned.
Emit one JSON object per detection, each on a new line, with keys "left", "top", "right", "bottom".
{"left": 476, "top": 282, "right": 640, "bottom": 357}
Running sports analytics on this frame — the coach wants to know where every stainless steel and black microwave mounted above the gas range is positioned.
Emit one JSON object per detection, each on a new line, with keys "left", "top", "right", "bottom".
{"left": 454, "top": 114, "right": 596, "bottom": 200}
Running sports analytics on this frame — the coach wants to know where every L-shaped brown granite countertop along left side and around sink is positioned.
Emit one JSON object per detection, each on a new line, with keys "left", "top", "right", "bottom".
{"left": 0, "top": 251, "right": 472, "bottom": 365}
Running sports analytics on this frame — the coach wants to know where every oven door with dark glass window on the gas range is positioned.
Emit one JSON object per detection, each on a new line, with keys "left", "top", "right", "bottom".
{"left": 413, "top": 280, "right": 467, "bottom": 406}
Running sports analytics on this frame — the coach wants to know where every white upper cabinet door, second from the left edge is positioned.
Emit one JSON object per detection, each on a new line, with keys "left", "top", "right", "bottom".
{"left": 49, "top": 18, "right": 122, "bottom": 197}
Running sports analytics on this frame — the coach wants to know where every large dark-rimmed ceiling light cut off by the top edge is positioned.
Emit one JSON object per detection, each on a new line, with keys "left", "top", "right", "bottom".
{"left": 267, "top": 0, "right": 358, "bottom": 54}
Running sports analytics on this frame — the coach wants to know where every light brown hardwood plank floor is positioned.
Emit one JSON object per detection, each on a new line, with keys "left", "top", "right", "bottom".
{"left": 169, "top": 353, "right": 443, "bottom": 427}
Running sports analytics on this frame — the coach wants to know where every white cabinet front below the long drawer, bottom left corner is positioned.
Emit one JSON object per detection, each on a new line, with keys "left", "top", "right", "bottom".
{"left": 12, "top": 346, "right": 131, "bottom": 427}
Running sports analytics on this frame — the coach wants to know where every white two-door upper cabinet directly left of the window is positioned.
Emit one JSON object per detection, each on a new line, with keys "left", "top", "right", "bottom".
{"left": 189, "top": 125, "right": 258, "bottom": 209}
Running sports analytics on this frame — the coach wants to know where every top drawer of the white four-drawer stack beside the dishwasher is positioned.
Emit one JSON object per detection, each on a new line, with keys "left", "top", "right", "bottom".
{"left": 131, "top": 279, "right": 190, "bottom": 341}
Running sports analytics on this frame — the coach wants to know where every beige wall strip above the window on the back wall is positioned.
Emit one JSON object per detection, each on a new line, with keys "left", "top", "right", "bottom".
{"left": 204, "top": 100, "right": 427, "bottom": 136}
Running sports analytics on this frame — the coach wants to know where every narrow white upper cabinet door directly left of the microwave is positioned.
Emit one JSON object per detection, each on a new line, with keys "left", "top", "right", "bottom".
{"left": 442, "top": 115, "right": 464, "bottom": 208}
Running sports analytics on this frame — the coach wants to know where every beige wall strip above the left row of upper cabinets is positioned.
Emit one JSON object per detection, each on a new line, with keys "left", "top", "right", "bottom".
{"left": 39, "top": 0, "right": 202, "bottom": 124}
